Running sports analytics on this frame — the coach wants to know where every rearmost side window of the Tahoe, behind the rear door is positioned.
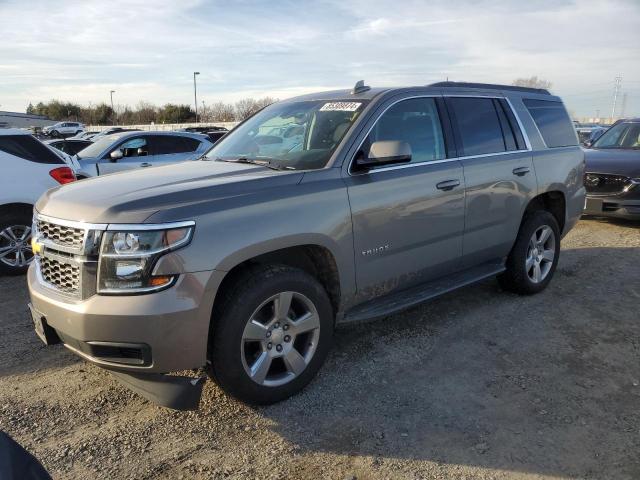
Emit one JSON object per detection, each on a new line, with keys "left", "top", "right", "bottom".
{"left": 522, "top": 99, "right": 578, "bottom": 147}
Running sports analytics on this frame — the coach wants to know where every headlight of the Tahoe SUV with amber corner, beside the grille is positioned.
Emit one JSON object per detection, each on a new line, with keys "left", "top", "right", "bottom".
{"left": 98, "top": 222, "right": 194, "bottom": 294}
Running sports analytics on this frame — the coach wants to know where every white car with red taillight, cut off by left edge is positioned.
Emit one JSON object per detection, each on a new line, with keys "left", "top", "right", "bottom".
{"left": 0, "top": 129, "right": 76, "bottom": 275}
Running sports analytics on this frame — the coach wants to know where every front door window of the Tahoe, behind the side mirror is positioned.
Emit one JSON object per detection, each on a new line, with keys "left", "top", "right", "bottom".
{"left": 363, "top": 98, "right": 447, "bottom": 163}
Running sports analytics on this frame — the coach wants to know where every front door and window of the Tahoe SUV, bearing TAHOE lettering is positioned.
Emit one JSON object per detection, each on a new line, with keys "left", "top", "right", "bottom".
{"left": 345, "top": 97, "right": 464, "bottom": 301}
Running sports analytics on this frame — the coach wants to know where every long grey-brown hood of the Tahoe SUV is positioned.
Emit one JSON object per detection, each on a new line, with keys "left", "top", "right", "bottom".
{"left": 36, "top": 161, "right": 303, "bottom": 223}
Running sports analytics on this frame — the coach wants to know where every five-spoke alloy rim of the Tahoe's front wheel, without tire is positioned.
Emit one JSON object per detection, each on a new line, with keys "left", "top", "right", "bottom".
{"left": 241, "top": 292, "right": 320, "bottom": 387}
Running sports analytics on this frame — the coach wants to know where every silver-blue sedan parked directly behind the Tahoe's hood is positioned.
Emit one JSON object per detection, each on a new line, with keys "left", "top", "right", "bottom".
{"left": 71, "top": 131, "right": 213, "bottom": 178}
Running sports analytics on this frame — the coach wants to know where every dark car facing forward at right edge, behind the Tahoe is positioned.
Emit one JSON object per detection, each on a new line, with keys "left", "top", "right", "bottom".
{"left": 584, "top": 118, "right": 640, "bottom": 220}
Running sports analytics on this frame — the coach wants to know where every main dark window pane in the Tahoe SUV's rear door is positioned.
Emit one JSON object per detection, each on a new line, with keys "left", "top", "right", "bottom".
{"left": 448, "top": 97, "right": 506, "bottom": 156}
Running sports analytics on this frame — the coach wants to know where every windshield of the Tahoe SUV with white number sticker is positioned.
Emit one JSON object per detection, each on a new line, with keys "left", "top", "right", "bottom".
{"left": 206, "top": 100, "right": 366, "bottom": 170}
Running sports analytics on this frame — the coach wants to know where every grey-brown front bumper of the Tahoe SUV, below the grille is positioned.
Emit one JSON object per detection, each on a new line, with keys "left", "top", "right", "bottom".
{"left": 27, "top": 263, "right": 222, "bottom": 373}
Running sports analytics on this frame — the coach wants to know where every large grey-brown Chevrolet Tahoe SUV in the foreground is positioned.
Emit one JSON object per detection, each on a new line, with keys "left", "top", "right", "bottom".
{"left": 28, "top": 82, "right": 585, "bottom": 408}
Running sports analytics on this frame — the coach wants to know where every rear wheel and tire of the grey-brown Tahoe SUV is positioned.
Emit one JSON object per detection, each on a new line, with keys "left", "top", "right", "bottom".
{"left": 498, "top": 210, "right": 560, "bottom": 295}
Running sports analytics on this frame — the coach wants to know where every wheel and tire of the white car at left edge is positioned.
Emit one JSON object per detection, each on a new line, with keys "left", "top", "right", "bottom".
{"left": 0, "top": 210, "right": 33, "bottom": 275}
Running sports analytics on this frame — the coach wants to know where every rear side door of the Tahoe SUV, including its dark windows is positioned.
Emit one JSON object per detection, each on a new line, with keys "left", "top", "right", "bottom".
{"left": 446, "top": 96, "right": 538, "bottom": 268}
